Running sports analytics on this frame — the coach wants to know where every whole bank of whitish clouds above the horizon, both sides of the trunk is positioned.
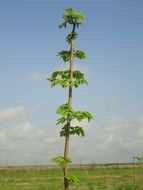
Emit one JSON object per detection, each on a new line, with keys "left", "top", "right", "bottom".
{"left": 0, "top": 104, "right": 143, "bottom": 165}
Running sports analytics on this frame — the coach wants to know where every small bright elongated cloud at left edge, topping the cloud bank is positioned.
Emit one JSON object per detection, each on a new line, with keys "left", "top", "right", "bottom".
{"left": 0, "top": 106, "right": 25, "bottom": 123}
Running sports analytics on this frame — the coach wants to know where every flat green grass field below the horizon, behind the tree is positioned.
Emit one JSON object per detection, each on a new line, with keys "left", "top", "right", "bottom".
{"left": 0, "top": 166, "right": 143, "bottom": 190}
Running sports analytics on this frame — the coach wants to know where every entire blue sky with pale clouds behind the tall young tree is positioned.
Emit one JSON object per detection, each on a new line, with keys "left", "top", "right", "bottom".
{"left": 0, "top": 0, "right": 143, "bottom": 166}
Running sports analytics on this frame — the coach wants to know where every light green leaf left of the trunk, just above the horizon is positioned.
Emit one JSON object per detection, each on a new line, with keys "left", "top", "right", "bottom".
{"left": 52, "top": 156, "right": 72, "bottom": 167}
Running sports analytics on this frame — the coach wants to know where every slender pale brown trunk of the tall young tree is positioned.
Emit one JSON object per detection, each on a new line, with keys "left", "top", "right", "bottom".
{"left": 63, "top": 40, "right": 74, "bottom": 190}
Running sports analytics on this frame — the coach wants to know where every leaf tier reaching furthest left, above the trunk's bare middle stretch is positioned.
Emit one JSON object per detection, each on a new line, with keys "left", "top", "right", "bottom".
{"left": 47, "top": 70, "right": 88, "bottom": 88}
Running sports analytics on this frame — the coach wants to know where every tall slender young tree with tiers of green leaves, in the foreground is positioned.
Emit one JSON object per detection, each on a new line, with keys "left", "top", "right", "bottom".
{"left": 48, "top": 8, "right": 93, "bottom": 190}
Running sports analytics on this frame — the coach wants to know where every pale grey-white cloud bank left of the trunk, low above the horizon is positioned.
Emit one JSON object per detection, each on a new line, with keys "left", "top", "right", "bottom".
{"left": 0, "top": 113, "right": 62, "bottom": 165}
